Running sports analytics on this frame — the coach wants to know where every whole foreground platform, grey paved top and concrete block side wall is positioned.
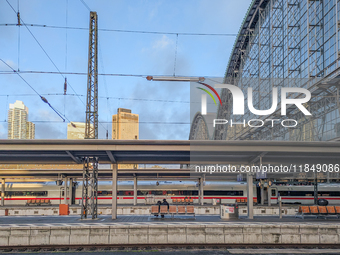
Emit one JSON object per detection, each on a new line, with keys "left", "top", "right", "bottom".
{"left": 0, "top": 215, "right": 340, "bottom": 247}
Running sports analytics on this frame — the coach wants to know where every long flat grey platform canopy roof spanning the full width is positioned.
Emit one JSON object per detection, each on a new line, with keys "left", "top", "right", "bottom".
{"left": 0, "top": 139, "right": 340, "bottom": 178}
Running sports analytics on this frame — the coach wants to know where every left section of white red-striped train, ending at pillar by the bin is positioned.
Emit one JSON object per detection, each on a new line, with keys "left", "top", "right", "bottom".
{"left": 1, "top": 181, "right": 251, "bottom": 205}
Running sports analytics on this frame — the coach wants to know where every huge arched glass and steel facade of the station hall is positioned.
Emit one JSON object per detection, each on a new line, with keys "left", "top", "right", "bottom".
{"left": 210, "top": 0, "right": 340, "bottom": 141}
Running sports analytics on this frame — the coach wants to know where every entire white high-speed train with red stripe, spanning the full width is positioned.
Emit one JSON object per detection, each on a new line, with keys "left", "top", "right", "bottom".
{"left": 5, "top": 181, "right": 340, "bottom": 205}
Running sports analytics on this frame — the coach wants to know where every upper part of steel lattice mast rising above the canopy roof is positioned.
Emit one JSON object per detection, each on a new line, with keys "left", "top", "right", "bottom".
{"left": 85, "top": 12, "right": 98, "bottom": 139}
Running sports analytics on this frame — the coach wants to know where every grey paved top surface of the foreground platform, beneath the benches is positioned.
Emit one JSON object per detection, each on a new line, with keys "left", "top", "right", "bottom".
{"left": 0, "top": 215, "right": 340, "bottom": 227}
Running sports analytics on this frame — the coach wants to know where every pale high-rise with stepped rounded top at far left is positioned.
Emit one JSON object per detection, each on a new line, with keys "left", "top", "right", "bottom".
{"left": 8, "top": 100, "right": 35, "bottom": 139}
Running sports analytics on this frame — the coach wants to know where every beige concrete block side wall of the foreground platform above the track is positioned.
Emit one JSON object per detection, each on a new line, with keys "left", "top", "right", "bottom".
{"left": 0, "top": 224, "right": 340, "bottom": 247}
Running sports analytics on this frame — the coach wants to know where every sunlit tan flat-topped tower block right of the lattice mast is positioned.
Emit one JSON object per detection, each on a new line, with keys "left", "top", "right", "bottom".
{"left": 112, "top": 108, "right": 139, "bottom": 169}
